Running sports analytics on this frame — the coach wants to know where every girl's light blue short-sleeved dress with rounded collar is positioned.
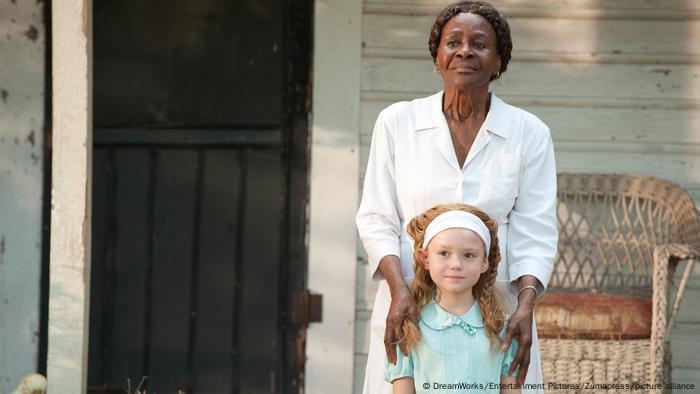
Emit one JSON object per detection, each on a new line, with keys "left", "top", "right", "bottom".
{"left": 384, "top": 300, "right": 517, "bottom": 394}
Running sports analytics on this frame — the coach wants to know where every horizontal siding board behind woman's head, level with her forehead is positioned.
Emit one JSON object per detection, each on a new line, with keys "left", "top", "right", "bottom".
{"left": 363, "top": 14, "right": 700, "bottom": 55}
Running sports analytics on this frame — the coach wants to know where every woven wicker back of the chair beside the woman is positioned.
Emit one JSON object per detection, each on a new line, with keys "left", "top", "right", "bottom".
{"left": 548, "top": 173, "right": 700, "bottom": 296}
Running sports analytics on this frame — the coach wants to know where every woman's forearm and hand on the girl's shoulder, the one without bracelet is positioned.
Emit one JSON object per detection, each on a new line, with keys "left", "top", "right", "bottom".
{"left": 379, "top": 255, "right": 419, "bottom": 365}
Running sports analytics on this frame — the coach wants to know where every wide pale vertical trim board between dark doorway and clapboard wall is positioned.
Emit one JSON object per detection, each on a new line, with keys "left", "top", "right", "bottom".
{"left": 305, "top": 0, "right": 362, "bottom": 394}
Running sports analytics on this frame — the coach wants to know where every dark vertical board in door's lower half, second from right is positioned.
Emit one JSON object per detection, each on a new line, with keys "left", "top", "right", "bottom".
{"left": 194, "top": 150, "right": 241, "bottom": 392}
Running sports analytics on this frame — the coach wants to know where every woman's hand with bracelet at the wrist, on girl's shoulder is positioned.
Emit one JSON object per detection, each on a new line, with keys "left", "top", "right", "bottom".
{"left": 502, "top": 280, "right": 536, "bottom": 384}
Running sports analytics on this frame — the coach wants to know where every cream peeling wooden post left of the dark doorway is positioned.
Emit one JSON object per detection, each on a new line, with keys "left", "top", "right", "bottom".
{"left": 47, "top": 0, "right": 92, "bottom": 393}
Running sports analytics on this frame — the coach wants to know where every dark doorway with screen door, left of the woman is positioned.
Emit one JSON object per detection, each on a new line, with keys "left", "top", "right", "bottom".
{"left": 88, "top": 0, "right": 312, "bottom": 393}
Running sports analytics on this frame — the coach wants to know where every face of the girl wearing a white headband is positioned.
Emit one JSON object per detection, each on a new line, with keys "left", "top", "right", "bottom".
{"left": 419, "top": 228, "right": 489, "bottom": 295}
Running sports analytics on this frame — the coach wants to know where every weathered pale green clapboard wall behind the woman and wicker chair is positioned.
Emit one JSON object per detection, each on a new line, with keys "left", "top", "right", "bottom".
{"left": 354, "top": 0, "right": 700, "bottom": 392}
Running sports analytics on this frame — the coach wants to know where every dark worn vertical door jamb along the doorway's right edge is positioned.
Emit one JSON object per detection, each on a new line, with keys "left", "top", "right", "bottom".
{"left": 284, "top": 0, "right": 314, "bottom": 393}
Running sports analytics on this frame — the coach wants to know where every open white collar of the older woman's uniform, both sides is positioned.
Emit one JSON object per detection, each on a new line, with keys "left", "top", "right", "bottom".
{"left": 415, "top": 91, "right": 511, "bottom": 138}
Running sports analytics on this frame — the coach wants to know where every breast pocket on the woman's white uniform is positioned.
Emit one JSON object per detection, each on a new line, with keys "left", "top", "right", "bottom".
{"left": 487, "top": 153, "right": 522, "bottom": 218}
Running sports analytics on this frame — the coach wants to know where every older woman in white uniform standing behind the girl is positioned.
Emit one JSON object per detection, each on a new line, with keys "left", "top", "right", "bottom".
{"left": 357, "top": 1, "right": 557, "bottom": 394}
